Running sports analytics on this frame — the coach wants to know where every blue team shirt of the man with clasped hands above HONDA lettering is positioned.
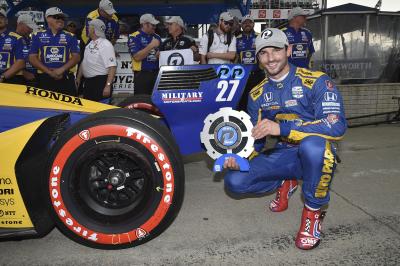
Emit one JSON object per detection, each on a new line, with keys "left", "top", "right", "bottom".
{"left": 29, "top": 29, "right": 80, "bottom": 73}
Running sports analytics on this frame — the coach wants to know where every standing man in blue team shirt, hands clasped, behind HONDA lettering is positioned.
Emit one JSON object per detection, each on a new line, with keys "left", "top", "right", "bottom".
{"left": 29, "top": 7, "right": 80, "bottom": 96}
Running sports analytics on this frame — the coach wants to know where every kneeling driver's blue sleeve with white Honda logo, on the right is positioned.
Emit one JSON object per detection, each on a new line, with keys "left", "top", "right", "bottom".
{"left": 280, "top": 75, "right": 347, "bottom": 141}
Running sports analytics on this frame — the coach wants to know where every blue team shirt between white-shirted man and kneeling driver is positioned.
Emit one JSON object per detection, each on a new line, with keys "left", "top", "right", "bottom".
{"left": 236, "top": 31, "right": 260, "bottom": 71}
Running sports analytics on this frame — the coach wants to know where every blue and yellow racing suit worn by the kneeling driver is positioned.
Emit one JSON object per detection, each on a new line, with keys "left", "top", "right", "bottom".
{"left": 225, "top": 65, "right": 347, "bottom": 209}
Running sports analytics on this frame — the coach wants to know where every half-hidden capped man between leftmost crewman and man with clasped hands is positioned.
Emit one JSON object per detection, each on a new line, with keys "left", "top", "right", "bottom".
{"left": 15, "top": 14, "right": 39, "bottom": 87}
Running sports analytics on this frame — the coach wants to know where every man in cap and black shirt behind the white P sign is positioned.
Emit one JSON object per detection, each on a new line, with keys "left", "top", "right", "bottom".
{"left": 160, "top": 16, "right": 200, "bottom": 61}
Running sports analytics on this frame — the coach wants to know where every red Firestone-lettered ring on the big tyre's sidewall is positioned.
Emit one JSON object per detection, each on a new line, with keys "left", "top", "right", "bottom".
{"left": 49, "top": 124, "right": 175, "bottom": 244}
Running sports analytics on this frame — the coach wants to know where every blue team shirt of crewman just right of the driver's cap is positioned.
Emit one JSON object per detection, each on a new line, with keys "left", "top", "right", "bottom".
{"left": 282, "top": 26, "right": 315, "bottom": 68}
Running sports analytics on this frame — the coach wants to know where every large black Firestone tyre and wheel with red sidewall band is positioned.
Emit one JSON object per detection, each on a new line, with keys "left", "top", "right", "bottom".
{"left": 45, "top": 109, "right": 184, "bottom": 249}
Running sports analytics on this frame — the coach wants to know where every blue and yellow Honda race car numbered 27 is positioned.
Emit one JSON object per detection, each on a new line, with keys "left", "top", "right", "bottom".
{"left": 0, "top": 65, "right": 250, "bottom": 249}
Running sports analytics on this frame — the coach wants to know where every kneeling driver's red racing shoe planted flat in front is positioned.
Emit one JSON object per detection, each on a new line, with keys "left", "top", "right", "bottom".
{"left": 295, "top": 206, "right": 325, "bottom": 250}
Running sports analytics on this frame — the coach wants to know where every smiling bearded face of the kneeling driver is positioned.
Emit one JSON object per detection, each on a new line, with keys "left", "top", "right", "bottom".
{"left": 257, "top": 46, "right": 291, "bottom": 79}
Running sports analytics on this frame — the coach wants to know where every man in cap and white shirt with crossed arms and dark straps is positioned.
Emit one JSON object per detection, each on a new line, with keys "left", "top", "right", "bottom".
{"left": 199, "top": 12, "right": 236, "bottom": 64}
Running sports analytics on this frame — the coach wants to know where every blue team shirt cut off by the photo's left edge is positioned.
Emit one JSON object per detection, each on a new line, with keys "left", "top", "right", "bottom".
{"left": 0, "top": 31, "right": 26, "bottom": 74}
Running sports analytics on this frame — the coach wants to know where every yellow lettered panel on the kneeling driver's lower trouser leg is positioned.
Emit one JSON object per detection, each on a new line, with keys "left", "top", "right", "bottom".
{"left": 315, "top": 141, "right": 335, "bottom": 198}
